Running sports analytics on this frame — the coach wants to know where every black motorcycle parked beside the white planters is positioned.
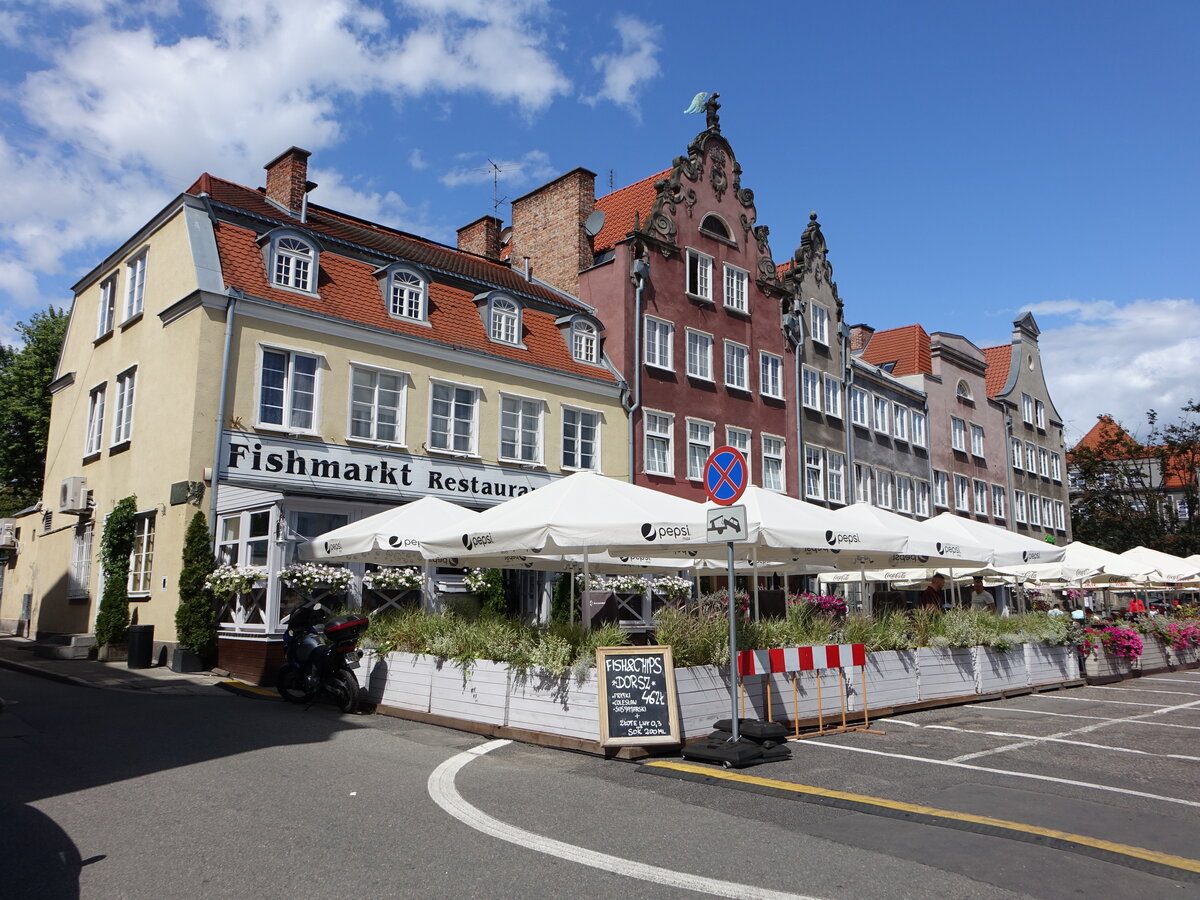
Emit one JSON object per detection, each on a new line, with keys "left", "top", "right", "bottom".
{"left": 275, "top": 601, "right": 370, "bottom": 713}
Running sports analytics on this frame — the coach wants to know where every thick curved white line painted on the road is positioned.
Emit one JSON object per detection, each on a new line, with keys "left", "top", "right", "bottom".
{"left": 427, "top": 740, "right": 815, "bottom": 900}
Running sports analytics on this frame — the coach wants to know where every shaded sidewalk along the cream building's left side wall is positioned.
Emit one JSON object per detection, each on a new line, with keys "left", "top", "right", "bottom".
{"left": 0, "top": 635, "right": 224, "bottom": 695}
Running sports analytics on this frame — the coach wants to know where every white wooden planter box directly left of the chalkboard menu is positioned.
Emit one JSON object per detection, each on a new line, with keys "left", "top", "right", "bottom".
{"left": 505, "top": 670, "right": 600, "bottom": 740}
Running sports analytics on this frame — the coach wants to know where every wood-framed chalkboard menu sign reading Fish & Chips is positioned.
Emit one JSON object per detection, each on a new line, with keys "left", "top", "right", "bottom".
{"left": 596, "top": 647, "right": 679, "bottom": 746}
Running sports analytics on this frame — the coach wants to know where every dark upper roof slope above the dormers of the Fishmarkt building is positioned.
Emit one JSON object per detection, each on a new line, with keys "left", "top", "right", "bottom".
{"left": 188, "top": 174, "right": 586, "bottom": 312}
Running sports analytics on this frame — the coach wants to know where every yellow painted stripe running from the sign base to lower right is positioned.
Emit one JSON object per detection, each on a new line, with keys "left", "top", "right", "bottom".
{"left": 646, "top": 761, "right": 1200, "bottom": 880}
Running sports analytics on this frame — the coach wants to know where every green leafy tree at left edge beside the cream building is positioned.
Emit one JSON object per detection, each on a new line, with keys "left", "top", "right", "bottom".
{"left": 0, "top": 306, "right": 68, "bottom": 516}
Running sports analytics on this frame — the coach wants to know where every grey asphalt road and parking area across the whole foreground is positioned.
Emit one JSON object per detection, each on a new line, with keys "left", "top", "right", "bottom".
{"left": 0, "top": 671, "right": 1200, "bottom": 900}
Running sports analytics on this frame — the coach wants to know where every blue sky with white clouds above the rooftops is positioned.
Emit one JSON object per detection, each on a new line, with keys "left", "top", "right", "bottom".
{"left": 0, "top": 0, "right": 1200, "bottom": 446}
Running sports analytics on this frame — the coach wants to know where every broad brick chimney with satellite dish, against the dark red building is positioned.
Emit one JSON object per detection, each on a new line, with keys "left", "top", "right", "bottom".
{"left": 509, "top": 168, "right": 596, "bottom": 296}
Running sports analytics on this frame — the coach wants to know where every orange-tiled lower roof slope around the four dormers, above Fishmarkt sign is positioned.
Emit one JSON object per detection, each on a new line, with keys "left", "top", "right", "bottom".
{"left": 208, "top": 222, "right": 614, "bottom": 382}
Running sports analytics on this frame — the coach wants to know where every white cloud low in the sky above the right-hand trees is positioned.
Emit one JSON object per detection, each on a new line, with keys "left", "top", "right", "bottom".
{"left": 1025, "top": 299, "right": 1200, "bottom": 446}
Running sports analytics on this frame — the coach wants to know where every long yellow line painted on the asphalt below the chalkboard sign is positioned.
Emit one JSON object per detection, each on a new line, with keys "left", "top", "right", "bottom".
{"left": 646, "top": 761, "right": 1200, "bottom": 872}
